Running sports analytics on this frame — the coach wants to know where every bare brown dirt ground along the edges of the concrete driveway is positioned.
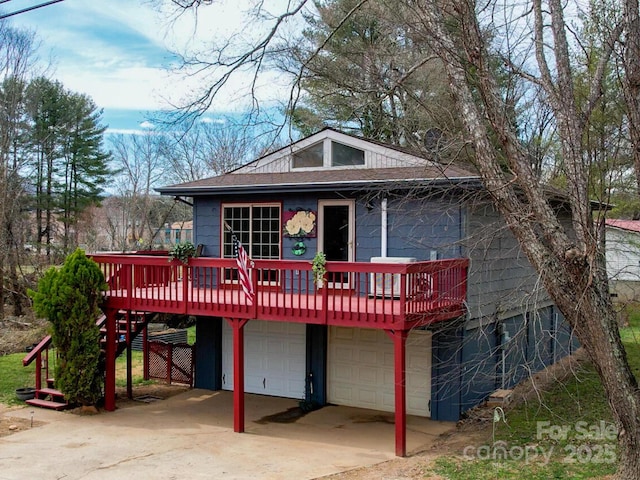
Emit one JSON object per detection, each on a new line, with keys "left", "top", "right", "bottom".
{"left": 0, "top": 344, "right": 586, "bottom": 480}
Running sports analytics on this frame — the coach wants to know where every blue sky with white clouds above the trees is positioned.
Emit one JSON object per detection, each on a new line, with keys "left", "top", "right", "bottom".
{"left": 5, "top": 0, "right": 300, "bottom": 133}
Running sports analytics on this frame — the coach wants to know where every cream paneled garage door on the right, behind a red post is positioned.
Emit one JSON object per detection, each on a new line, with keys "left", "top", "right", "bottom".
{"left": 327, "top": 327, "right": 431, "bottom": 417}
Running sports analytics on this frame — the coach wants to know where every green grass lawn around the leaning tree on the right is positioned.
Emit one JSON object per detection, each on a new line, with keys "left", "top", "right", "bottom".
{"left": 430, "top": 311, "right": 640, "bottom": 480}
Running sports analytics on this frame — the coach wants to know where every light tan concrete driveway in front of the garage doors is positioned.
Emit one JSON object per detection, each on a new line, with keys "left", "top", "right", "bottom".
{"left": 0, "top": 389, "right": 454, "bottom": 480}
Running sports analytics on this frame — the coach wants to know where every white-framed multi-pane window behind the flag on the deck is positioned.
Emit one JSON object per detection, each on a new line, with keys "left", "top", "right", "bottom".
{"left": 222, "top": 204, "right": 281, "bottom": 281}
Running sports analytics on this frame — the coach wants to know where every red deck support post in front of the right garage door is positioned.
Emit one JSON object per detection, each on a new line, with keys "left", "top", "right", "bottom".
{"left": 385, "top": 330, "right": 408, "bottom": 457}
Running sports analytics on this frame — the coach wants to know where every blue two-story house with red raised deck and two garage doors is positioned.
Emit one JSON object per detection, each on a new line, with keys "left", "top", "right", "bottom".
{"left": 97, "top": 129, "right": 576, "bottom": 455}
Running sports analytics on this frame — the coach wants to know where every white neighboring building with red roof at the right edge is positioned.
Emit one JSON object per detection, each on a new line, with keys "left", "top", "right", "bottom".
{"left": 606, "top": 219, "right": 640, "bottom": 302}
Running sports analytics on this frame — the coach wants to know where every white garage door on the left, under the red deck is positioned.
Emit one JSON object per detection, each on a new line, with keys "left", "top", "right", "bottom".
{"left": 222, "top": 320, "right": 306, "bottom": 398}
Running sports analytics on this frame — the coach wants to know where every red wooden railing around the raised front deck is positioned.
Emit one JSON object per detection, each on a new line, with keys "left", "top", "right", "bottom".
{"left": 93, "top": 255, "right": 468, "bottom": 327}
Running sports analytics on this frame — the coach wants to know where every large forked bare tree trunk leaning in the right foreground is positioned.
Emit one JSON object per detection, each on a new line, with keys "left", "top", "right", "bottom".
{"left": 424, "top": 0, "right": 640, "bottom": 480}
